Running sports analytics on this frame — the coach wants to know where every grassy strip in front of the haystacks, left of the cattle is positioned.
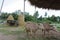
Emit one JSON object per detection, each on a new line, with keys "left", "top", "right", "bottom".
{"left": 0, "top": 24, "right": 24, "bottom": 35}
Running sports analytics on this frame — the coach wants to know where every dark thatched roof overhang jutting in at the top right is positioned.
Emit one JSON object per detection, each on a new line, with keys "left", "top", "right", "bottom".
{"left": 29, "top": 0, "right": 60, "bottom": 10}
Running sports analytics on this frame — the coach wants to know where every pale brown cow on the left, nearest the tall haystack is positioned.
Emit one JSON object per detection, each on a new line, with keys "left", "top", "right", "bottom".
{"left": 25, "top": 22, "right": 39, "bottom": 36}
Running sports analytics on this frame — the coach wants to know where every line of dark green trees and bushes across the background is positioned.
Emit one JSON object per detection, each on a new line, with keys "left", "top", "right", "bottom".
{"left": 0, "top": 11, "right": 60, "bottom": 23}
